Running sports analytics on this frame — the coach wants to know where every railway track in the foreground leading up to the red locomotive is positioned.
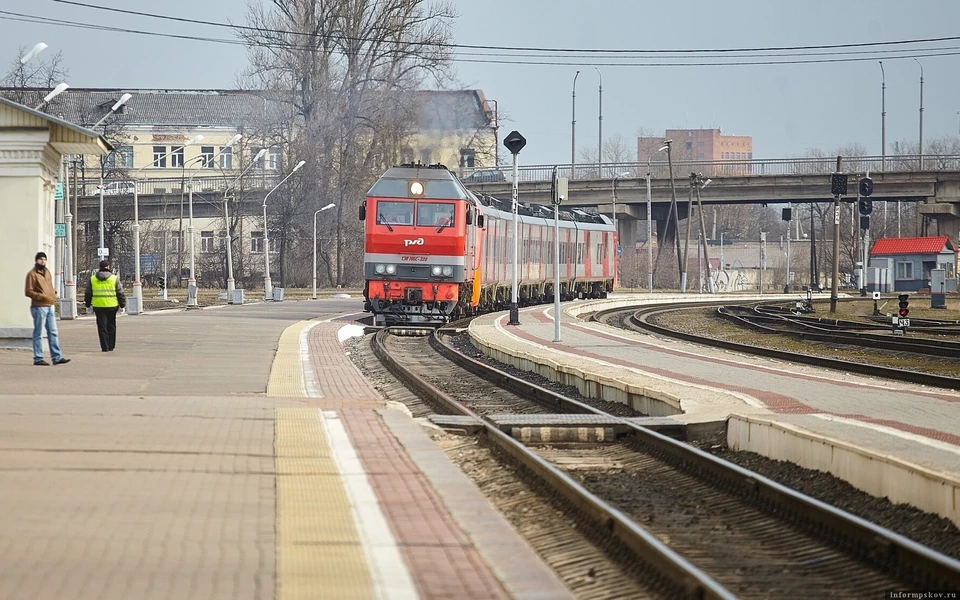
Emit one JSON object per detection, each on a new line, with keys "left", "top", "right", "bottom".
{"left": 372, "top": 329, "right": 960, "bottom": 598}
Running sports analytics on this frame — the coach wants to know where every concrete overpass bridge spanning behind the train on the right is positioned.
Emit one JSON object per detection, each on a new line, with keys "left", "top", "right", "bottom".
{"left": 469, "top": 155, "right": 960, "bottom": 240}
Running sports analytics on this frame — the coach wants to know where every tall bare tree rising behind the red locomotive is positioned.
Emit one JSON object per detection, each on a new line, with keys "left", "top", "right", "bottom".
{"left": 238, "top": 0, "right": 456, "bottom": 285}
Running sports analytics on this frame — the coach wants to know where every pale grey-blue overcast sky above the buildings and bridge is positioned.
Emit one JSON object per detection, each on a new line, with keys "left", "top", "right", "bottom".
{"left": 0, "top": 0, "right": 960, "bottom": 164}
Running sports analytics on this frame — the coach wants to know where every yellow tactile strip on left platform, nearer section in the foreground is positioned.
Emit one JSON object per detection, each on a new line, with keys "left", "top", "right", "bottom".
{"left": 275, "top": 408, "right": 376, "bottom": 600}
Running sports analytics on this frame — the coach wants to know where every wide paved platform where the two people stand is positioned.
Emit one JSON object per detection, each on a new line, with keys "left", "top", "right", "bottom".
{"left": 0, "top": 300, "right": 570, "bottom": 600}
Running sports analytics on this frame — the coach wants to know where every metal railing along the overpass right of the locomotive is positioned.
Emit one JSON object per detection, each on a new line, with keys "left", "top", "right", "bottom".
{"left": 504, "top": 154, "right": 960, "bottom": 182}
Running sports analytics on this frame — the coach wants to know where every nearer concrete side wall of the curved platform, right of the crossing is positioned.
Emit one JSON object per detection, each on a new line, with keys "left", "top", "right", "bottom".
{"left": 727, "top": 414, "right": 960, "bottom": 525}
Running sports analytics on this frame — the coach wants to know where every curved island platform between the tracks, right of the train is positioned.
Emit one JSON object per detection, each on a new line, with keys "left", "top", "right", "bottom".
{"left": 469, "top": 294, "right": 960, "bottom": 525}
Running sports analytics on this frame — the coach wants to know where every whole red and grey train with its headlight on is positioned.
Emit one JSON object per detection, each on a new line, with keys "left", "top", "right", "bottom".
{"left": 360, "top": 165, "right": 616, "bottom": 326}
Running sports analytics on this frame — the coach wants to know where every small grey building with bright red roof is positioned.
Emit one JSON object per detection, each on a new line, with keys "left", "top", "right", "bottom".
{"left": 867, "top": 235, "right": 957, "bottom": 292}
